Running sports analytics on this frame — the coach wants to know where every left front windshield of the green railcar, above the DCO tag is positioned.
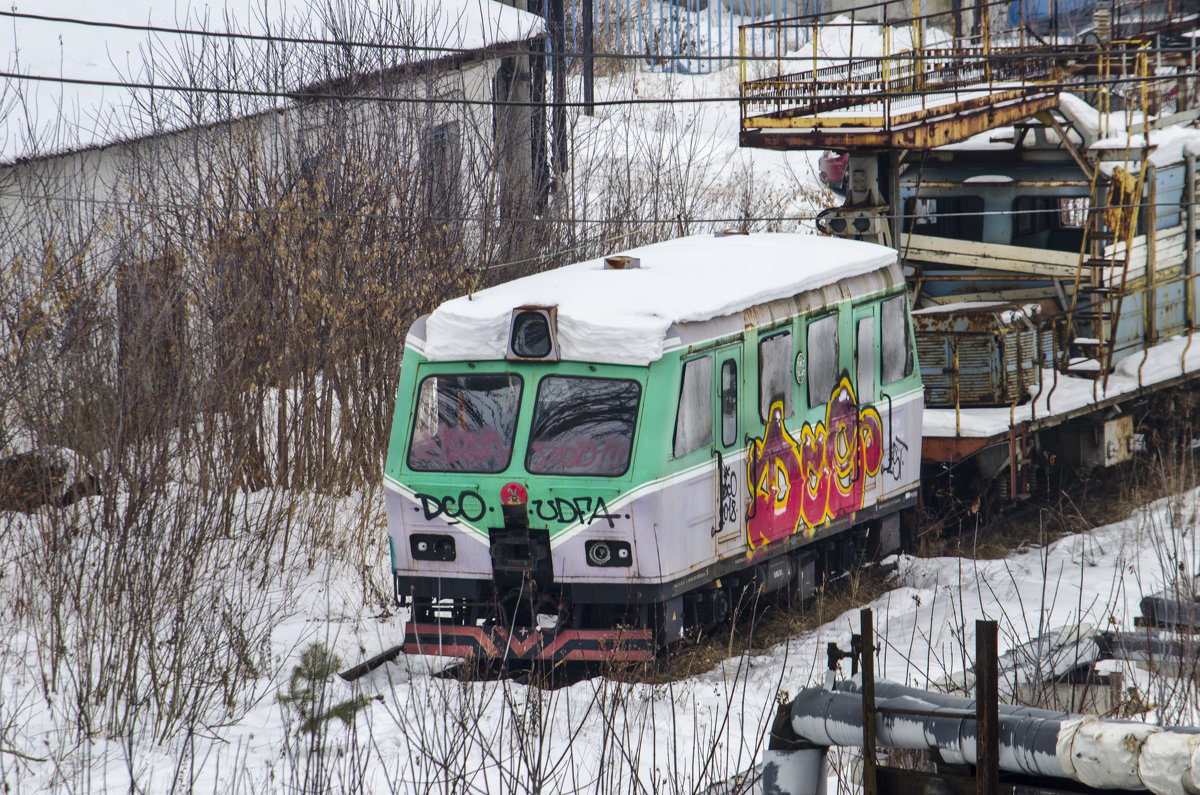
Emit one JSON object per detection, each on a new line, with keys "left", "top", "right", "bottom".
{"left": 408, "top": 373, "right": 522, "bottom": 472}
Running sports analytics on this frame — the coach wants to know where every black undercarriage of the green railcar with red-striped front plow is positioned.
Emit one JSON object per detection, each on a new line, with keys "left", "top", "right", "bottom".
{"left": 396, "top": 504, "right": 916, "bottom": 663}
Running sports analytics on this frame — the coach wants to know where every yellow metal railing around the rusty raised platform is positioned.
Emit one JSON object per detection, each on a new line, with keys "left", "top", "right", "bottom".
{"left": 739, "top": 0, "right": 1185, "bottom": 138}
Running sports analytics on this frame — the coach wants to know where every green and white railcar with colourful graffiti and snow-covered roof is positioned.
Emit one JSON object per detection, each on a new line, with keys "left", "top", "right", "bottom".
{"left": 385, "top": 229, "right": 923, "bottom": 659}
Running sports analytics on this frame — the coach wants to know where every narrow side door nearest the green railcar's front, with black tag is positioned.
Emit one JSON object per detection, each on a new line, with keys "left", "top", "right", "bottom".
{"left": 713, "top": 345, "right": 745, "bottom": 552}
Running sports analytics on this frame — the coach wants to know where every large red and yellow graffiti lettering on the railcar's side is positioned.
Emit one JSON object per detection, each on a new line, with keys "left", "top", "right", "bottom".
{"left": 746, "top": 376, "right": 883, "bottom": 546}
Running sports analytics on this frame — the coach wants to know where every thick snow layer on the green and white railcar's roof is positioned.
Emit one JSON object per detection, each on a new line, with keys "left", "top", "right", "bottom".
{"left": 424, "top": 234, "right": 896, "bottom": 365}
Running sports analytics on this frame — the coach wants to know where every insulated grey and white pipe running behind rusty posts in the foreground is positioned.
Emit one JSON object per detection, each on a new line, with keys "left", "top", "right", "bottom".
{"left": 791, "top": 681, "right": 1200, "bottom": 795}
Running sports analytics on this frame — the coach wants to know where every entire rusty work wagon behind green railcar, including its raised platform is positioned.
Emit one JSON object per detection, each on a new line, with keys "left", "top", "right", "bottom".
{"left": 740, "top": 0, "right": 1200, "bottom": 516}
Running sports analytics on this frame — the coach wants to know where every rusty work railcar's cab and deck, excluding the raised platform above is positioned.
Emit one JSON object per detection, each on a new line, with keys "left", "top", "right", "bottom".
{"left": 896, "top": 95, "right": 1200, "bottom": 504}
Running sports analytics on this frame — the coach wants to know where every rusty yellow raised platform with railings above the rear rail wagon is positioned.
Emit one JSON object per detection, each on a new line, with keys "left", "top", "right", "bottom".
{"left": 740, "top": 0, "right": 1200, "bottom": 151}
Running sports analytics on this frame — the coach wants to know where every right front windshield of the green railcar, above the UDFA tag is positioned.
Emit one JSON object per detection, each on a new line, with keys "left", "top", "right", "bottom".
{"left": 526, "top": 376, "right": 642, "bottom": 476}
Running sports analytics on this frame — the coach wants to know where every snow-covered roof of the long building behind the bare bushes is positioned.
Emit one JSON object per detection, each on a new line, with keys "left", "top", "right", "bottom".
{"left": 0, "top": 0, "right": 544, "bottom": 162}
